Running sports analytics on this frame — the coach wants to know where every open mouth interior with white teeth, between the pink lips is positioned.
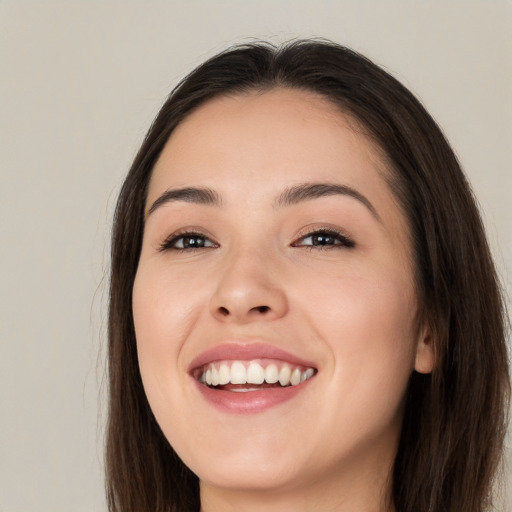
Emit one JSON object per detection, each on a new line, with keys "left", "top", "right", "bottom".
{"left": 194, "top": 359, "right": 316, "bottom": 392}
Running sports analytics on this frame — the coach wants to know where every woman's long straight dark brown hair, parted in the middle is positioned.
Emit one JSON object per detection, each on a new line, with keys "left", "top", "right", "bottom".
{"left": 106, "top": 41, "right": 510, "bottom": 512}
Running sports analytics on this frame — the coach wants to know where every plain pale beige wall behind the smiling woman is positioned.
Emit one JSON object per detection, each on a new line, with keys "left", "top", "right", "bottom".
{"left": 0, "top": 0, "right": 512, "bottom": 512}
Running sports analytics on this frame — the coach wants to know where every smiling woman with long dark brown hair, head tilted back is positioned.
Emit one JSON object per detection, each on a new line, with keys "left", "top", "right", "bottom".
{"left": 107, "top": 41, "right": 509, "bottom": 512}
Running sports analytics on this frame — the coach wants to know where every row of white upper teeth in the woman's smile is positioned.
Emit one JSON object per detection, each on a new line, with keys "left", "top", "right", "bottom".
{"left": 199, "top": 361, "right": 315, "bottom": 386}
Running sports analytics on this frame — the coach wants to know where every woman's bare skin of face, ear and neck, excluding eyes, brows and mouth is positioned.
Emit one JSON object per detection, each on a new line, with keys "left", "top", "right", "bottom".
{"left": 133, "top": 88, "right": 433, "bottom": 512}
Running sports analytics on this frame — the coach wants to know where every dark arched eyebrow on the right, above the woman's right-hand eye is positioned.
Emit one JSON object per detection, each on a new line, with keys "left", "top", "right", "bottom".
{"left": 275, "top": 183, "right": 381, "bottom": 221}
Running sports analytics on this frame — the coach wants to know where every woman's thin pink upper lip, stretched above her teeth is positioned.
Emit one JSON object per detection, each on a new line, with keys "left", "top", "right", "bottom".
{"left": 189, "top": 342, "right": 316, "bottom": 372}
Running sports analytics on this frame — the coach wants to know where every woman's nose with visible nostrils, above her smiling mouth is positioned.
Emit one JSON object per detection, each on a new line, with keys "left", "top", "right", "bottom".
{"left": 210, "top": 249, "right": 288, "bottom": 324}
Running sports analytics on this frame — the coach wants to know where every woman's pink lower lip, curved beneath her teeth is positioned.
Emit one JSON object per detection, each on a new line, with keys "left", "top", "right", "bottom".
{"left": 194, "top": 379, "right": 312, "bottom": 414}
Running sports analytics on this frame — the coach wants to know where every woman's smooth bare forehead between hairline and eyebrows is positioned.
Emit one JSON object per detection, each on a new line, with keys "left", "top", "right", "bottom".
{"left": 148, "top": 88, "right": 389, "bottom": 202}
